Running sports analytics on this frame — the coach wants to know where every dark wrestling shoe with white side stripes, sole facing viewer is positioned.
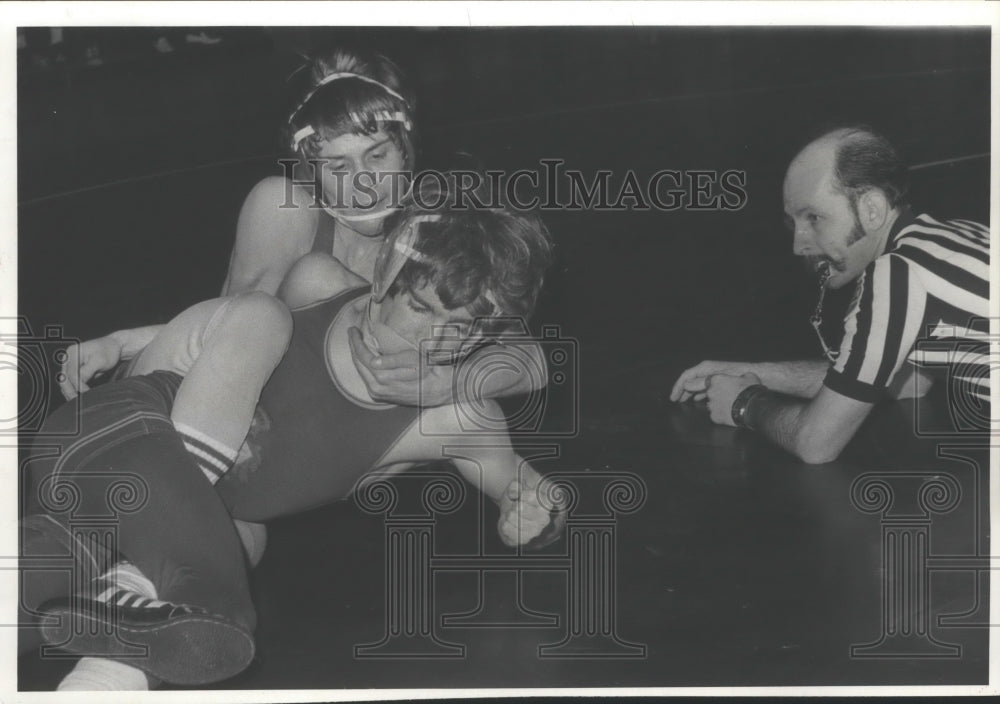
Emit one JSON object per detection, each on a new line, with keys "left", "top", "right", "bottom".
{"left": 41, "top": 581, "right": 254, "bottom": 686}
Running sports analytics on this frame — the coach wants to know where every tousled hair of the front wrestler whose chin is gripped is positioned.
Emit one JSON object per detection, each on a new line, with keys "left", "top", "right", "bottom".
{"left": 386, "top": 171, "right": 553, "bottom": 331}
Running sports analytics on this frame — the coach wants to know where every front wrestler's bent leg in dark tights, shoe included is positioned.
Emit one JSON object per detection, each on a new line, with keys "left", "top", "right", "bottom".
{"left": 23, "top": 372, "right": 256, "bottom": 684}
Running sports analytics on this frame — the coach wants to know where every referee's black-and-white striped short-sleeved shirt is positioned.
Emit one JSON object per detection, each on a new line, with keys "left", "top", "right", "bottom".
{"left": 824, "top": 213, "right": 990, "bottom": 403}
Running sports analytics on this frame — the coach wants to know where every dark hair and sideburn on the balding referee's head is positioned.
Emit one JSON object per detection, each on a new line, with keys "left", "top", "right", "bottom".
{"left": 834, "top": 125, "right": 910, "bottom": 210}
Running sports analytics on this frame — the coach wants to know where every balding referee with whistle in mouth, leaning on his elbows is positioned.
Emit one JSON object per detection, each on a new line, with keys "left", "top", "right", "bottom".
{"left": 670, "top": 126, "right": 989, "bottom": 463}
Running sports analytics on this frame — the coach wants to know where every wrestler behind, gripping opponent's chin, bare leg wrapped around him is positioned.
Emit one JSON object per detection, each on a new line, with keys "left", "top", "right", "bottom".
{"left": 60, "top": 49, "right": 545, "bottom": 553}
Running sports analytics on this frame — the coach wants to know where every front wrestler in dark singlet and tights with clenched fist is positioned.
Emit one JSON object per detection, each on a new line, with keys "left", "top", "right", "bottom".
{"left": 22, "top": 173, "right": 565, "bottom": 684}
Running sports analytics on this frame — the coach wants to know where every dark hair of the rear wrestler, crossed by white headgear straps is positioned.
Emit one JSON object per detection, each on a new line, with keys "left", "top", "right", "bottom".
{"left": 284, "top": 48, "right": 417, "bottom": 169}
